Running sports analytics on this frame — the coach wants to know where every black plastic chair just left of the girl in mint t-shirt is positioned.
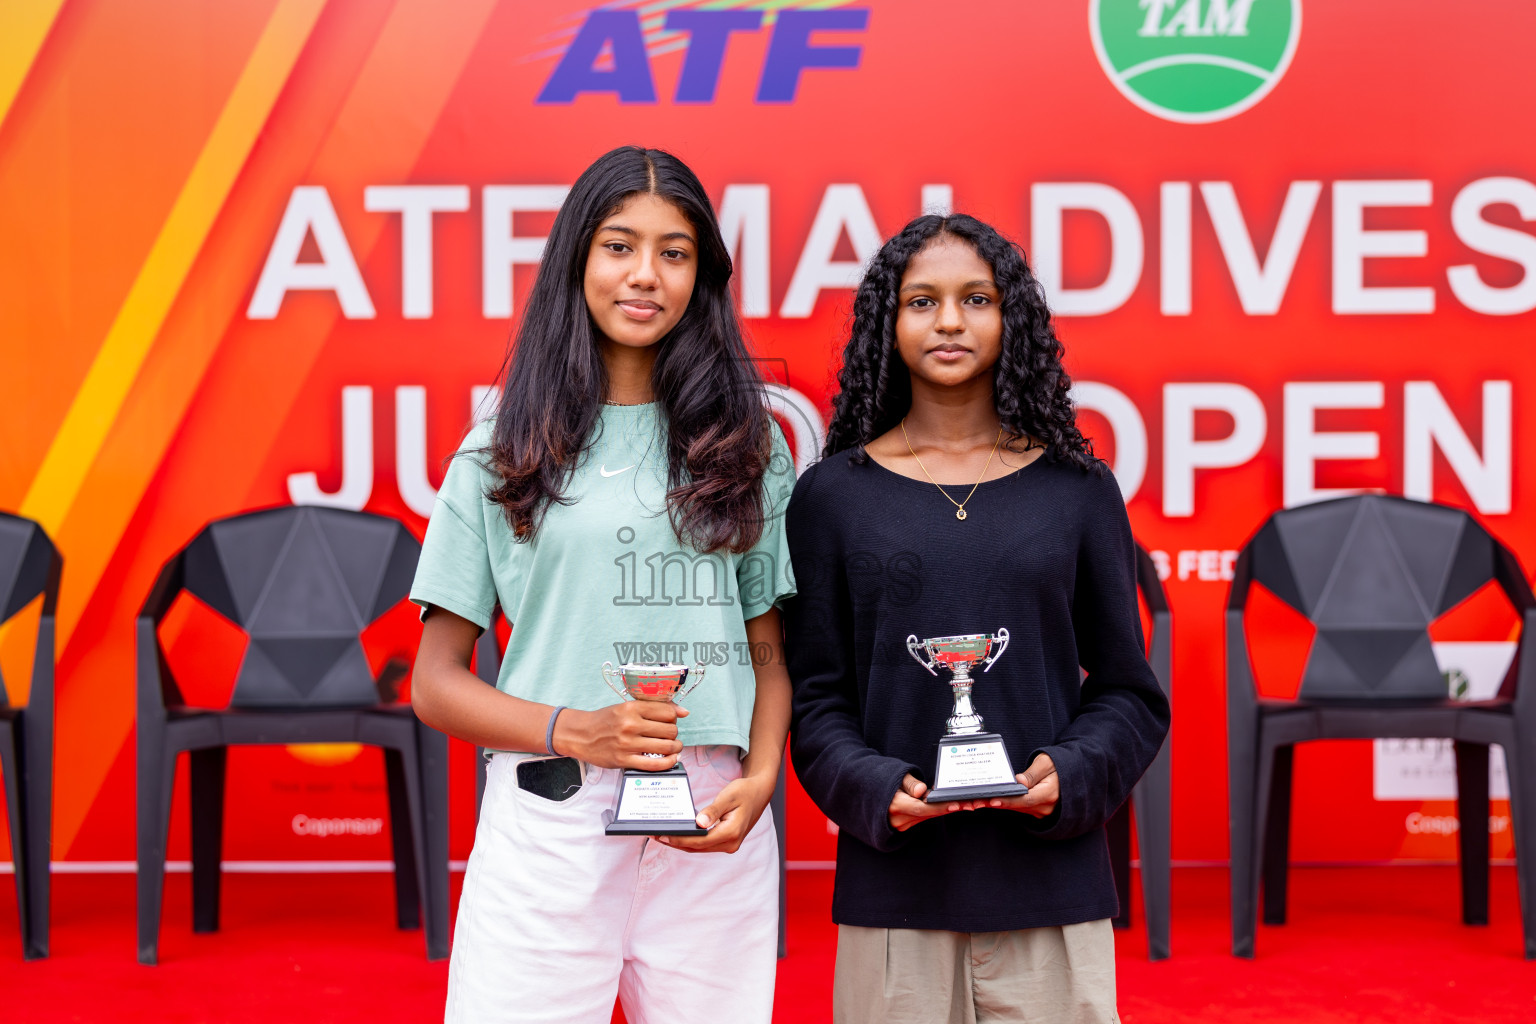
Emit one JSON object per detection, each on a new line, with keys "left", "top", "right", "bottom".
{"left": 138, "top": 507, "right": 449, "bottom": 964}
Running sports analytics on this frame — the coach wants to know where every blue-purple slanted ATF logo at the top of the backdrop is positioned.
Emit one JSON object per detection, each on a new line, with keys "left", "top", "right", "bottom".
{"left": 538, "top": 8, "right": 869, "bottom": 103}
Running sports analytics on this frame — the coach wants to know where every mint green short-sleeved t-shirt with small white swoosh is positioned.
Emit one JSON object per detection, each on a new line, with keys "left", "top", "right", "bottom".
{"left": 410, "top": 404, "right": 794, "bottom": 751}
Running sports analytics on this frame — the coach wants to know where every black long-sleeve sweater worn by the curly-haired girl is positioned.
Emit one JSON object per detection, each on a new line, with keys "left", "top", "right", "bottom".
{"left": 785, "top": 451, "right": 1169, "bottom": 932}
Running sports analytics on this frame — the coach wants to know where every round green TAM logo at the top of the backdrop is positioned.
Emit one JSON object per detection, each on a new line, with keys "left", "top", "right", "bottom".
{"left": 1087, "top": 0, "right": 1301, "bottom": 124}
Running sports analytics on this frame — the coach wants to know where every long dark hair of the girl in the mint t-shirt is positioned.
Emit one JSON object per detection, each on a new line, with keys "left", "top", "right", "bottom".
{"left": 487, "top": 146, "right": 773, "bottom": 551}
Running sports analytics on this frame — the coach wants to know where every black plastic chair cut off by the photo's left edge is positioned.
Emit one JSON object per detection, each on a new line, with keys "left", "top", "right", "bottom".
{"left": 0, "top": 513, "right": 65, "bottom": 960}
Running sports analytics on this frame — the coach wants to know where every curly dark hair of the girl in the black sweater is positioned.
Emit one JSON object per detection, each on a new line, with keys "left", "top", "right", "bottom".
{"left": 822, "top": 213, "right": 1104, "bottom": 473}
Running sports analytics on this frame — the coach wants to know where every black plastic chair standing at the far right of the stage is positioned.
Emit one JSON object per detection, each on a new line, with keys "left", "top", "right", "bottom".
{"left": 1227, "top": 494, "right": 1536, "bottom": 960}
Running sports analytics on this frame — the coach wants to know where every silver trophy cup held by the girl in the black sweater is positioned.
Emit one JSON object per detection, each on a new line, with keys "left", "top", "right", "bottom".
{"left": 906, "top": 629, "right": 1029, "bottom": 803}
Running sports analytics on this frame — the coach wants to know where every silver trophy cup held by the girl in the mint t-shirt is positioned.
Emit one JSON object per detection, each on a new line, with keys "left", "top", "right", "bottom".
{"left": 602, "top": 662, "right": 708, "bottom": 835}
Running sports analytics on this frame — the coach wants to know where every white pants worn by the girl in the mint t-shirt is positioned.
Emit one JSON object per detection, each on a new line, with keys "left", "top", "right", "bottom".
{"left": 444, "top": 746, "right": 779, "bottom": 1024}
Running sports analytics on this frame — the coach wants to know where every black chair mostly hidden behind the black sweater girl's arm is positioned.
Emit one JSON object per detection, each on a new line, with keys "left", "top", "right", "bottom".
{"left": 1106, "top": 545, "right": 1174, "bottom": 960}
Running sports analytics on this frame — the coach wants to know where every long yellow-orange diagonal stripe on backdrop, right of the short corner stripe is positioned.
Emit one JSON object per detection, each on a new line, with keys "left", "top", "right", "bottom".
{"left": 22, "top": 0, "right": 326, "bottom": 534}
